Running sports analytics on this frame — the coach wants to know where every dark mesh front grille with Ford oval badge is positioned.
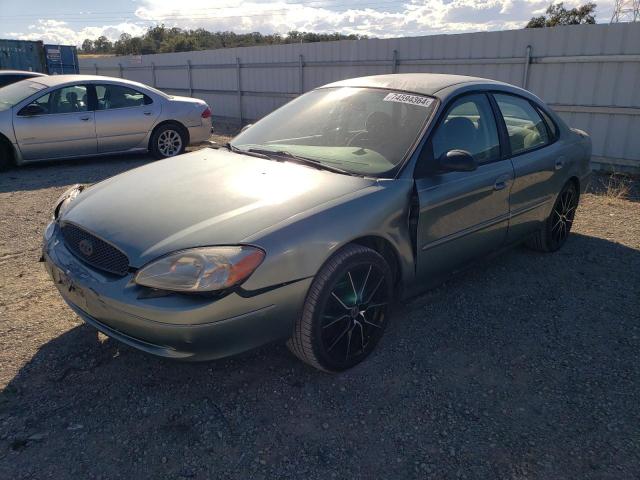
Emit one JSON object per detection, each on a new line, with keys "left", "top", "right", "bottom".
{"left": 62, "top": 223, "right": 129, "bottom": 276}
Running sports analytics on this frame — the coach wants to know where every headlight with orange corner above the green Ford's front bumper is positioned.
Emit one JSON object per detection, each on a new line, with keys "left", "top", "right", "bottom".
{"left": 135, "top": 246, "right": 265, "bottom": 293}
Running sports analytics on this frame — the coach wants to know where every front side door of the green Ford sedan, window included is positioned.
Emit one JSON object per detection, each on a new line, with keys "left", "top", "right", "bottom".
{"left": 416, "top": 93, "right": 514, "bottom": 286}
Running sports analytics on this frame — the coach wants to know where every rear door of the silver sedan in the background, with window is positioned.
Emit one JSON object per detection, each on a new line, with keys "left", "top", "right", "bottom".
{"left": 94, "top": 84, "right": 161, "bottom": 153}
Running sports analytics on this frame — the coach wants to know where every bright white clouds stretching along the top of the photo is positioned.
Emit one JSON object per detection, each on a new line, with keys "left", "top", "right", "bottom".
{"left": 2, "top": 0, "right": 614, "bottom": 45}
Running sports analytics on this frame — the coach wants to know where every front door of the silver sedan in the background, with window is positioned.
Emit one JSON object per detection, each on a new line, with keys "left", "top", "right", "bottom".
{"left": 13, "top": 85, "right": 97, "bottom": 160}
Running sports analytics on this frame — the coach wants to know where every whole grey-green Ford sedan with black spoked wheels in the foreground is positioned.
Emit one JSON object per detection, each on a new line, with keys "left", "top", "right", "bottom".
{"left": 43, "top": 74, "right": 591, "bottom": 372}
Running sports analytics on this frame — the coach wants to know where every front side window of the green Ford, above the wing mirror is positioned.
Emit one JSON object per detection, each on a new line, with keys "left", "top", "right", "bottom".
{"left": 432, "top": 94, "right": 500, "bottom": 164}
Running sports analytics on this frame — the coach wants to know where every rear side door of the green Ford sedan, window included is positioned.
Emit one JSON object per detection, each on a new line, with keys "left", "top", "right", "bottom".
{"left": 493, "top": 92, "right": 566, "bottom": 242}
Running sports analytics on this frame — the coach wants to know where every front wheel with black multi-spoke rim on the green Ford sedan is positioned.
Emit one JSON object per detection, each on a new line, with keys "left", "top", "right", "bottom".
{"left": 287, "top": 245, "right": 393, "bottom": 372}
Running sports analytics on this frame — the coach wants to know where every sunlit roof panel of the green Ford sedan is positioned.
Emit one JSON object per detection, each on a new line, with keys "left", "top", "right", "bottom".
{"left": 320, "top": 73, "right": 507, "bottom": 97}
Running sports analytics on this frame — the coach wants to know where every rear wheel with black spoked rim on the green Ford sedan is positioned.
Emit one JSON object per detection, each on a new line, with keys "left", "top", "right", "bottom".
{"left": 526, "top": 181, "right": 580, "bottom": 252}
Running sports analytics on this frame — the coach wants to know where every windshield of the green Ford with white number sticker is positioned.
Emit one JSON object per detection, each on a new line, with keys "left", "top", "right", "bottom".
{"left": 231, "top": 87, "right": 435, "bottom": 176}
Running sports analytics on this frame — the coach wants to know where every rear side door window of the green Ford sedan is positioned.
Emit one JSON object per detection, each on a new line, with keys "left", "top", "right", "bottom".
{"left": 494, "top": 94, "right": 549, "bottom": 155}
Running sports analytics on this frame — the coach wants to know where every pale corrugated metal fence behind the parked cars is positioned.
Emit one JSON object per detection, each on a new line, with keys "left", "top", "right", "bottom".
{"left": 80, "top": 23, "right": 640, "bottom": 171}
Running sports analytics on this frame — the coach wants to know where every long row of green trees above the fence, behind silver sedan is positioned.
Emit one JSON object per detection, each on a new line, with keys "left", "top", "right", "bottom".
{"left": 81, "top": 25, "right": 367, "bottom": 55}
